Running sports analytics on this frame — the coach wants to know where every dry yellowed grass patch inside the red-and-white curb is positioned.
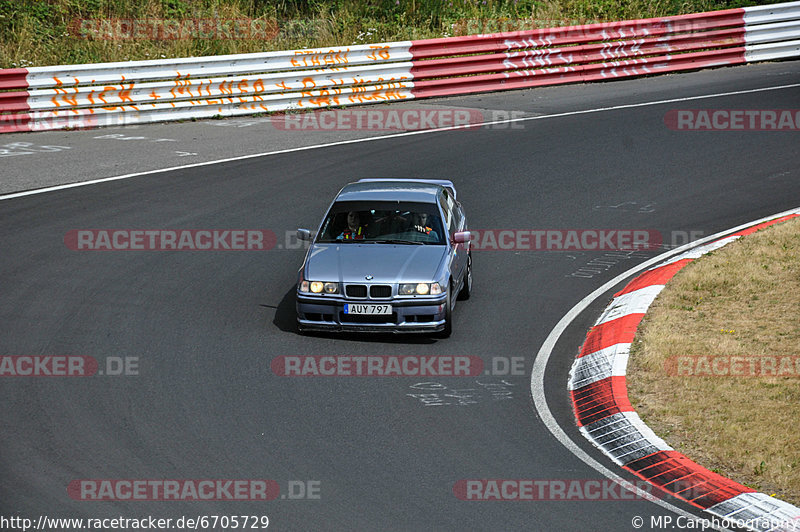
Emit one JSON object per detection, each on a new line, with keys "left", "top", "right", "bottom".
{"left": 628, "top": 215, "right": 800, "bottom": 505}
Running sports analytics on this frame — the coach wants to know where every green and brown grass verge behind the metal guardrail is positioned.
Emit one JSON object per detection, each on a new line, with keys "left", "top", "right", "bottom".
{"left": 0, "top": 0, "right": 778, "bottom": 68}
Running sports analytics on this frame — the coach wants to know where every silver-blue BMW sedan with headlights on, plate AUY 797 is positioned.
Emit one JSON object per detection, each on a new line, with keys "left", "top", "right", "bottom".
{"left": 297, "top": 178, "right": 472, "bottom": 337}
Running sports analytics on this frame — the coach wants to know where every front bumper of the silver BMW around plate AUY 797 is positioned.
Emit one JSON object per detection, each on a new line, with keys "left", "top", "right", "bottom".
{"left": 297, "top": 294, "right": 447, "bottom": 333}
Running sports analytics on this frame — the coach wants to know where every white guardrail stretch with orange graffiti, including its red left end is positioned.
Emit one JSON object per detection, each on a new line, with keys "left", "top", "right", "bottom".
{"left": 0, "top": 42, "right": 412, "bottom": 132}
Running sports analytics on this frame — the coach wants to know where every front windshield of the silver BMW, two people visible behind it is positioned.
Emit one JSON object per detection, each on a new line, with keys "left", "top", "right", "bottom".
{"left": 317, "top": 201, "right": 446, "bottom": 245}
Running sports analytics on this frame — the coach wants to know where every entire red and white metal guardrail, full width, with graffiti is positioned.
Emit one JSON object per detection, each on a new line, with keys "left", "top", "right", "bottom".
{"left": 0, "top": 2, "right": 800, "bottom": 132}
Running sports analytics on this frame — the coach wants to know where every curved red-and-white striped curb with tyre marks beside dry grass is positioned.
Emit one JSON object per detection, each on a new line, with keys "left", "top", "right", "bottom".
{"left": 568, "top": 212, "right": 800, "bottom": 531}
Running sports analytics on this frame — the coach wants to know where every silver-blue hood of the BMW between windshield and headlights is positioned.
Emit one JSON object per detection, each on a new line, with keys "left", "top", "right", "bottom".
{"left": 305, "top": 243, "right": 447, "bottom": 283}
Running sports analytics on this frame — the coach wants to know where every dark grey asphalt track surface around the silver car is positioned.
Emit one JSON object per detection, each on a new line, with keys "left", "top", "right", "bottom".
{"left": 0, "top": 61, "right": 800, "bottom": 530}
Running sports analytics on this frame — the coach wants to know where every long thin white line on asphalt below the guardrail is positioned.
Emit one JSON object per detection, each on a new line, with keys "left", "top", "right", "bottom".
{"left": 0, "top": 83, "right": 800, "bottom": 200}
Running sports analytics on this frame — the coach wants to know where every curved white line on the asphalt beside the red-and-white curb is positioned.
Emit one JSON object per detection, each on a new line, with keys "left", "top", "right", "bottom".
{"left": 531, "top": 205, "right": 800, "bottom": 530}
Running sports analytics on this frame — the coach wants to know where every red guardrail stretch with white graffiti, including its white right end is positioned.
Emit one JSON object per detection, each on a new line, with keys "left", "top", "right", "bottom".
{"left": 411, "top": 2, "right": 800, "bottom": 98}
